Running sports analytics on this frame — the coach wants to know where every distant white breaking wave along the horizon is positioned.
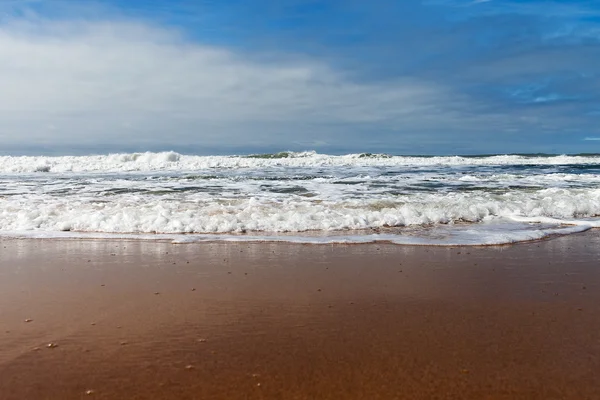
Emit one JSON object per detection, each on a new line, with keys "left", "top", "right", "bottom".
{"left": 0, "top": 151, "right": 600, "bottom": 174}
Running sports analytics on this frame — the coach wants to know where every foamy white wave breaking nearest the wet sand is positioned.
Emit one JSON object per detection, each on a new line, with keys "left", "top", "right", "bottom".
{"left": 0, "top": 188, "right": 600, "bottom": 233}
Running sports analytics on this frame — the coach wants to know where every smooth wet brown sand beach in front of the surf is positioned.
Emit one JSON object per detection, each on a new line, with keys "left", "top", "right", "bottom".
{"left": 0, "top": 231, "right": 600, "bottom": 400}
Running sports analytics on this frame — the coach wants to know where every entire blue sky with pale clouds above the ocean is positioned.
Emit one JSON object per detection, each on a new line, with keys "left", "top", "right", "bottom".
{"left": 0, "top": 0, "right": 600, "bottom": 155}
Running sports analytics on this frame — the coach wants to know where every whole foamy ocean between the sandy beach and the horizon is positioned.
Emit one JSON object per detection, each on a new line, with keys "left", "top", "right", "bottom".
{"left": 0, "top": 152, "right": 600, "bottom": 245}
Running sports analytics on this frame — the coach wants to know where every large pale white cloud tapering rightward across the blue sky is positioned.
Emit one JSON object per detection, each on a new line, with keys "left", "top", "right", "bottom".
{"left": 0, "top": 17, "right": 474, "bottom": 152}
